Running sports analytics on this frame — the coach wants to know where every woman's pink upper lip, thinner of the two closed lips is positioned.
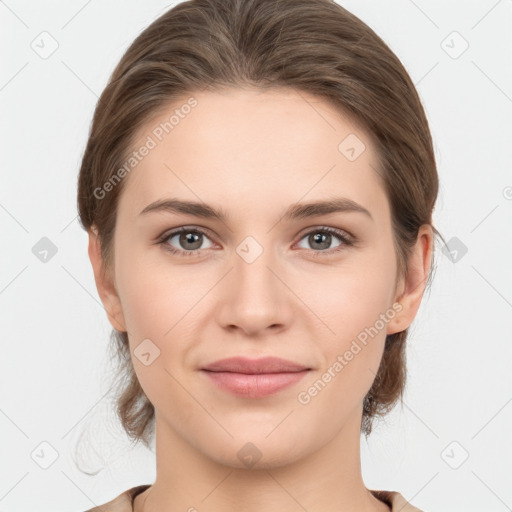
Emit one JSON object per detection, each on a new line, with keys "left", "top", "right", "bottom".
{"left": 202, "top": 356, "right": 311, "bottom": 374}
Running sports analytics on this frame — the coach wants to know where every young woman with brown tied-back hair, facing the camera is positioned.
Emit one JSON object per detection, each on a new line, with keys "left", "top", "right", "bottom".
{"left": 78, "top": 0, "right": 439, "bottom": 512}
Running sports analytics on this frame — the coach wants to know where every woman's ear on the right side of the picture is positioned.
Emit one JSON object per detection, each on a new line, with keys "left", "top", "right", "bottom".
{"left": 386, "top": 224, "right": 434, "bottom": 334}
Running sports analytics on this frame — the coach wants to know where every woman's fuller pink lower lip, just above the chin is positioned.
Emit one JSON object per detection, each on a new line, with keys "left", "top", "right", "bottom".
{"left": 202, "top": 370, "right": 309, "bottom": 398}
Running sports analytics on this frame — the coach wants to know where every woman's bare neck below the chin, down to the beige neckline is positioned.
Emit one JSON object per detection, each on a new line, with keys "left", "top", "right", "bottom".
{"left": 134, "top": 411, "right": 390, "bottom": 512}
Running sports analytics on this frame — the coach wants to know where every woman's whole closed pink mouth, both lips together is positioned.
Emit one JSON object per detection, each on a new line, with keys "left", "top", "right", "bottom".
{"left": 201, "top": 357, "right": 311, "bottom": 398}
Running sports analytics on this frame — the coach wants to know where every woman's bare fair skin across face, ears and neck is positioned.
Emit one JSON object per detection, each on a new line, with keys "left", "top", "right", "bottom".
{"left": 89, "top": 89, "right": 433, "bottom": 512}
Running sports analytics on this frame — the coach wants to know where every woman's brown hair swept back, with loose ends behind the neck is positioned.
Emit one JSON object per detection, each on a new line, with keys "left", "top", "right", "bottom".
{"left": 78, "top": 0, "right": 442, "bottom": 446}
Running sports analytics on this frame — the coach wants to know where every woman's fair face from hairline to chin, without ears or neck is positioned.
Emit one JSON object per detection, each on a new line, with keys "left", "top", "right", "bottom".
{"left": 93, "top": 89, "right": 412, "bottom": 467}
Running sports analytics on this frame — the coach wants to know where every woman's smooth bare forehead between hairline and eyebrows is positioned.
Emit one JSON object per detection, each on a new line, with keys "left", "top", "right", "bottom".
{"left": 119, "top": 88, "right": 387, "bottom": 223}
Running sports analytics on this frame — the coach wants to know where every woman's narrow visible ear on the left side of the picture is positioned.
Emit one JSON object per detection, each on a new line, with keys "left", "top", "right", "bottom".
{"left": 88, "top": 226, "right": 126, "bottom": 332}
